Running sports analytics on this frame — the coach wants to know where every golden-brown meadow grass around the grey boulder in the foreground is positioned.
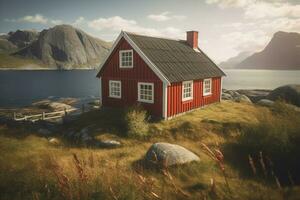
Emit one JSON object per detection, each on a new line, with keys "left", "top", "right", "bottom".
{"left": 0, "top": 101, "right": 300, "bottom": 199}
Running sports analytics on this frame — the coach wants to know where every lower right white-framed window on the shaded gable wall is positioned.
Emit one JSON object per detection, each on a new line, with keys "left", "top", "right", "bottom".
{"left": 138, "top": 82, "right": 154, "bottom": 103}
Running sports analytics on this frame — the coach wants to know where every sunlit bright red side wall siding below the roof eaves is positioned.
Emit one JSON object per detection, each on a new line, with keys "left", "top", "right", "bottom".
{"left": 167, "top": 77, "right": 221, "bottom": 117}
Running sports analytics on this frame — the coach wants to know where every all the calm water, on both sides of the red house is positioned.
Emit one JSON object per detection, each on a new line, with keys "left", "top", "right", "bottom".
{"left": 0, "top": 70, "right": 300, "bottom": 107}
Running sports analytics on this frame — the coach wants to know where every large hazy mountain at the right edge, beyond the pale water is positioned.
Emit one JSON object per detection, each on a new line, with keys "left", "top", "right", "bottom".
{"left": 236, "top": 31, "right": 300, "bottom": 70}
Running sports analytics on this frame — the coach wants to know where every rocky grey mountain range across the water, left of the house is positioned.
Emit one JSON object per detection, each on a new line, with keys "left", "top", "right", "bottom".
{"left": 0, "top": 25, "right": 111, "bottom": 69}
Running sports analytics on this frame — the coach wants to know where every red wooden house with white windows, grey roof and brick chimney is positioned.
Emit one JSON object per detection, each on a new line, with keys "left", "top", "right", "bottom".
{"left": 97, "top": 31, "right": 225, "bottom": 119}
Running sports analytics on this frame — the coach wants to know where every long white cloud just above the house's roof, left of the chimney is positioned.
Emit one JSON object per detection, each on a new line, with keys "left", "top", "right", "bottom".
{"left": 87, "top": 16, "right": 184, "bottom": 38}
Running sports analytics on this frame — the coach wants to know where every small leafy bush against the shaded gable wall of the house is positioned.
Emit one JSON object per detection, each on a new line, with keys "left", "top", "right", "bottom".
{"left": 124, "top": 105, "right": 149, "bottom": 138}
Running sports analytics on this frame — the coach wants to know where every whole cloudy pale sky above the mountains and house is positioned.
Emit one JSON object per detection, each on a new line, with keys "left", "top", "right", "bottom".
{"left": 0, "top": 0, "right": 300, "bottom": 62}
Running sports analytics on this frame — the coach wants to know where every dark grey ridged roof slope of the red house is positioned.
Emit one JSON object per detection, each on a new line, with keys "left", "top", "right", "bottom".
{"left": 126, "top": 32, "right": 225, "bottom": 82}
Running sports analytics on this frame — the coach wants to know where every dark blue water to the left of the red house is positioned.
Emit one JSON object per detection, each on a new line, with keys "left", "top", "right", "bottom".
{"left": 0, "top": 70, "right": 100, "bottom": 107}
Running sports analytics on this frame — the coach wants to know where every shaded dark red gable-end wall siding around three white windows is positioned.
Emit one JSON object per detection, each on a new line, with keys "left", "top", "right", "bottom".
{"left": 100, "top": 38, "right": 163, "bottom": 117}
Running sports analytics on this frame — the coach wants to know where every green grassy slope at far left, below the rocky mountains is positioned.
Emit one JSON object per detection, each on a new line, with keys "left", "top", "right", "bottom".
{"left": 0, "top": 52, "right": 45, "bottom": 69}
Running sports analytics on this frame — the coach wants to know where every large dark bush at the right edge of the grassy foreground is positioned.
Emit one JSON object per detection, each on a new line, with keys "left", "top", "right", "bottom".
{"left": 238, "top": 111, "right": 300, "bottom": 183}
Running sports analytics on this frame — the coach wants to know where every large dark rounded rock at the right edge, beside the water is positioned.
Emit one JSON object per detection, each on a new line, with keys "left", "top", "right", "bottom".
{"left": 267, "top": 85, "right": 300, "bottom": 107}
